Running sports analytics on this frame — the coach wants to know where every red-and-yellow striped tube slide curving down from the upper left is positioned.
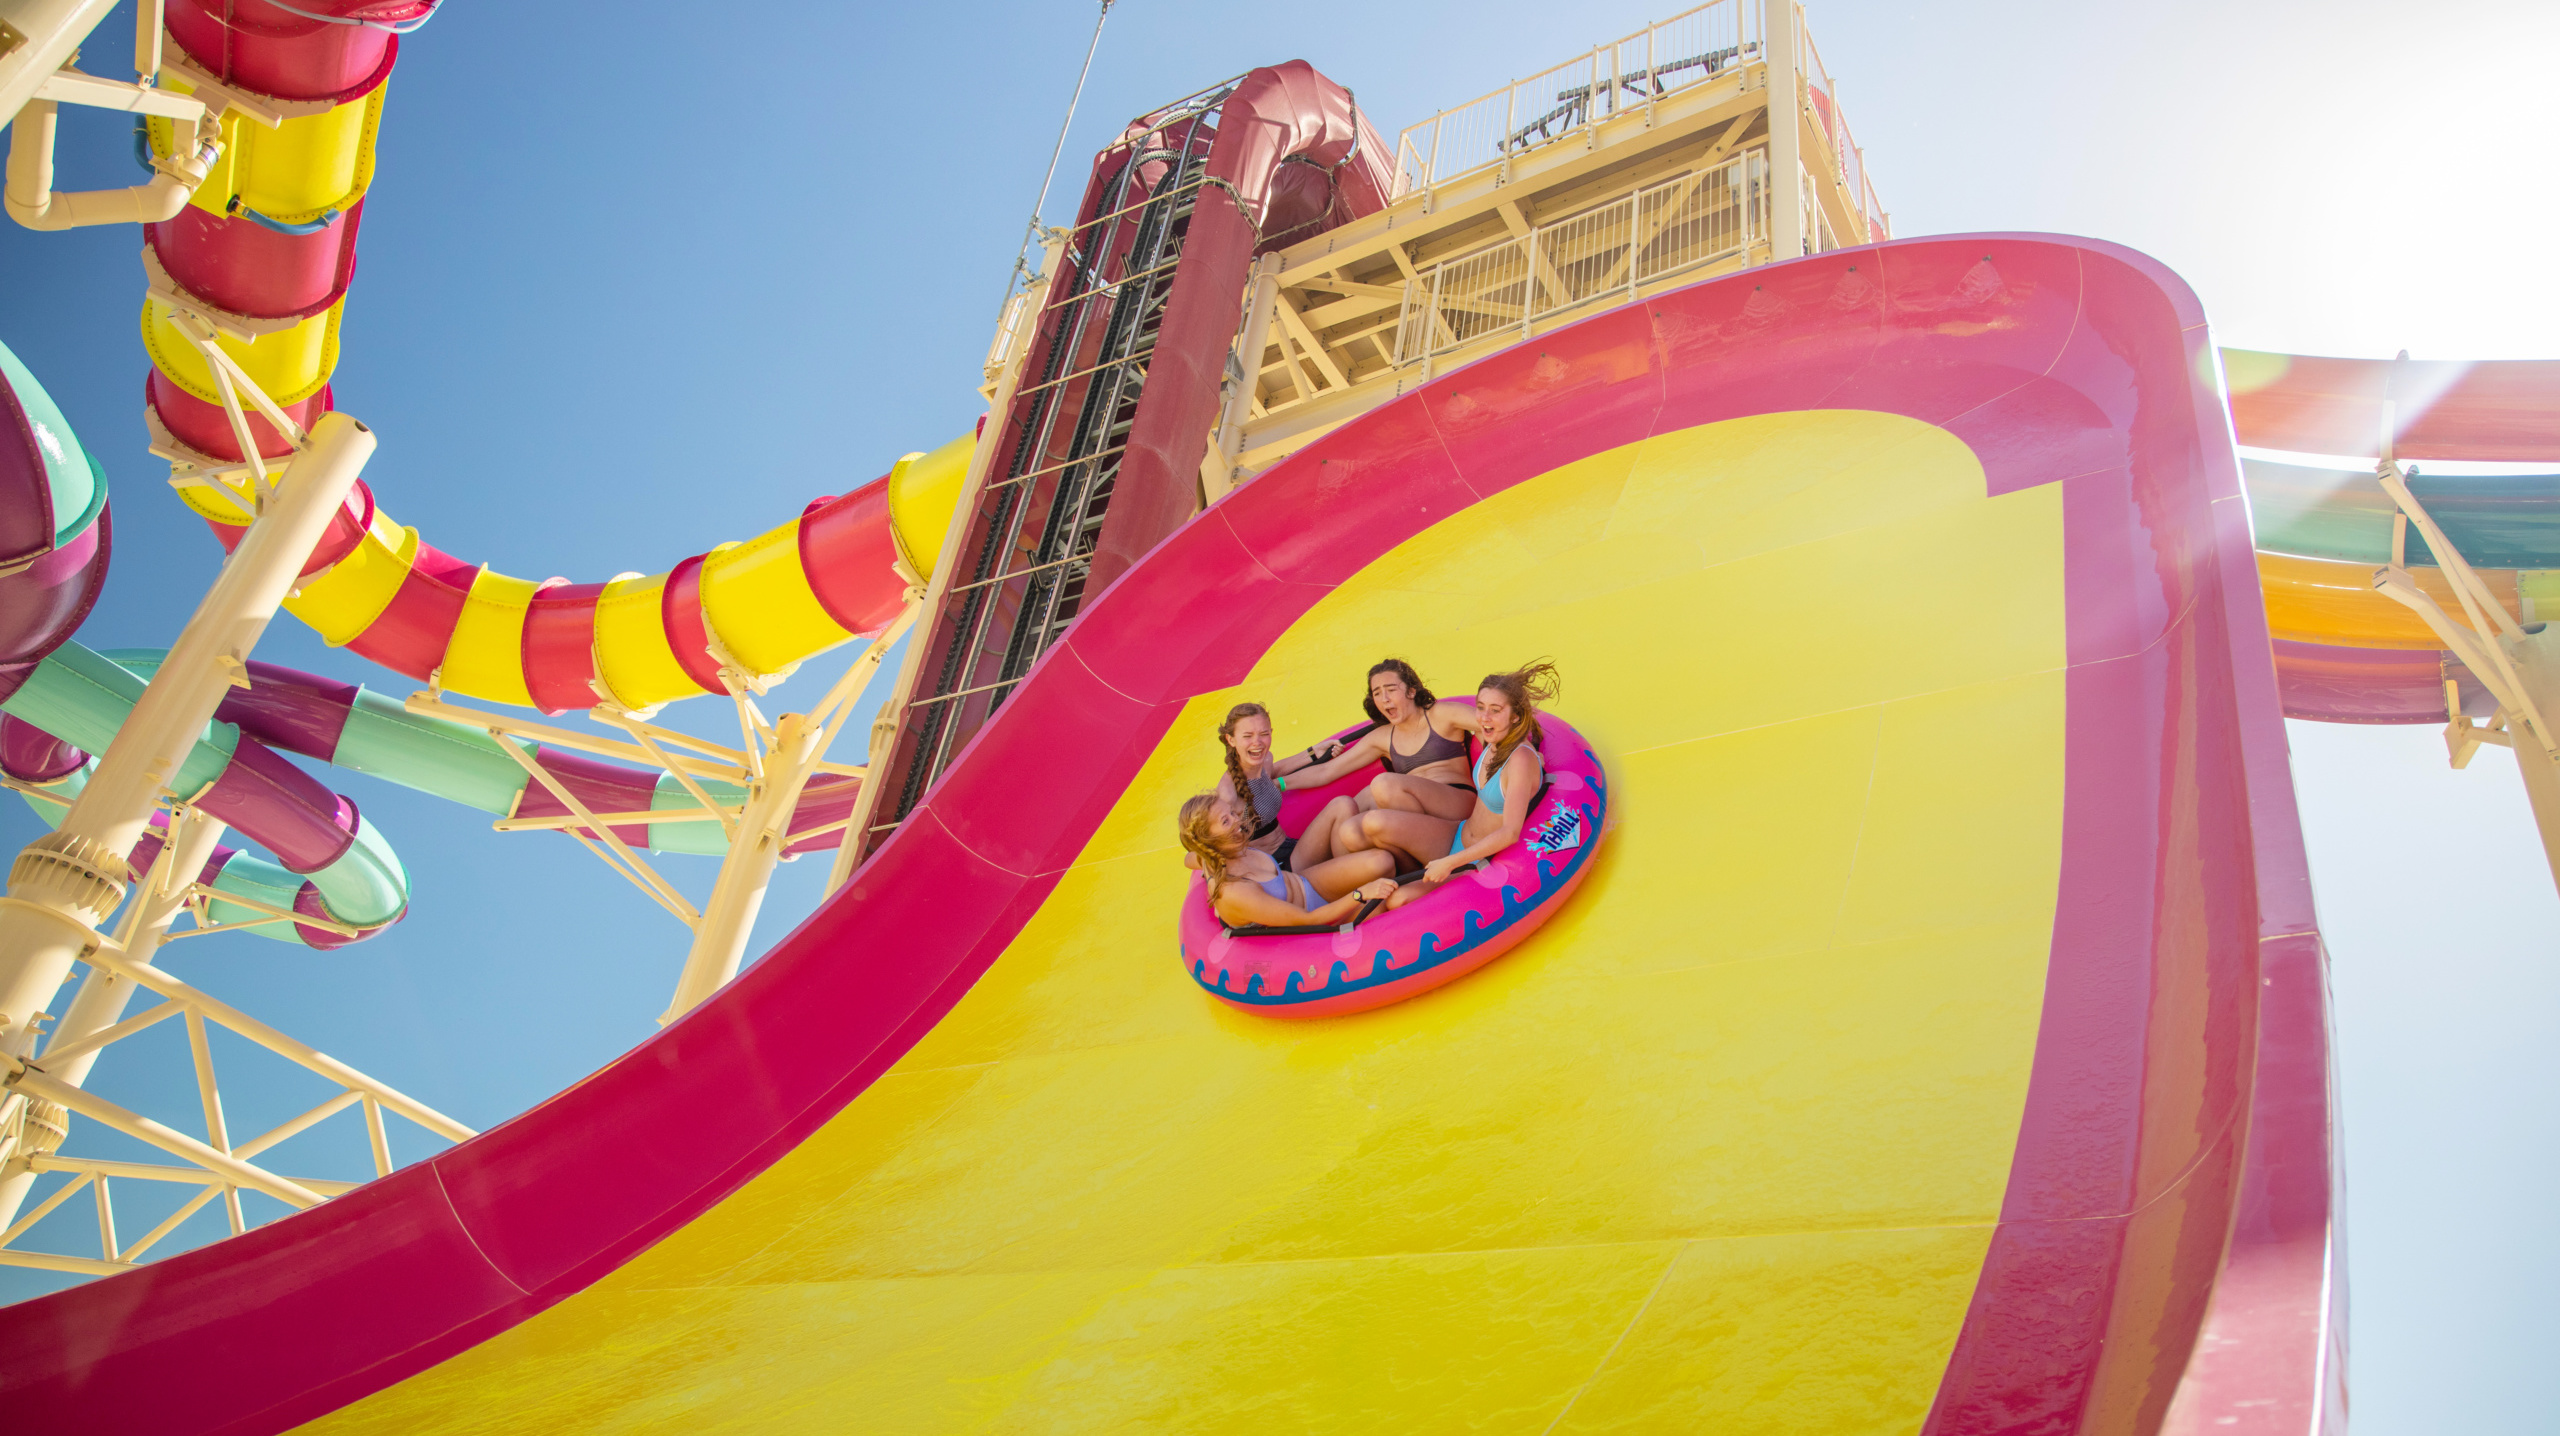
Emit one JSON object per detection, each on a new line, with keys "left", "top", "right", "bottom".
{"left": 143, "top": 0, "right": 975, "bottom": 712}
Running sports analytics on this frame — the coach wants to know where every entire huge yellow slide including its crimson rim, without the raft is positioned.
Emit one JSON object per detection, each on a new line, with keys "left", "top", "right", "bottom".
{"left": 0, "top": 235, "right": 2342, "bottom": 1436}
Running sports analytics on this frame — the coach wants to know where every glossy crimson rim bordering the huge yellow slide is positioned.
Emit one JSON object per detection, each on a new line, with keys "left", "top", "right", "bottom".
{"left": 0, "top": 235, "right": 2342, "bottom": 1436}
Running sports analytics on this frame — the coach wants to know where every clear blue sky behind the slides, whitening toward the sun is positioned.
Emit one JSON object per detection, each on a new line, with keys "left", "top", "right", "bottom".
{"left": 0, "top": 0, "right": 2560, "bottom": 1431}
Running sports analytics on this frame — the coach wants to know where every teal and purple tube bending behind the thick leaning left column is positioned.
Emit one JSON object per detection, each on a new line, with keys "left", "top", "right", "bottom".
{"left": 0, "top": 642, "right": 410, "bottom": 947}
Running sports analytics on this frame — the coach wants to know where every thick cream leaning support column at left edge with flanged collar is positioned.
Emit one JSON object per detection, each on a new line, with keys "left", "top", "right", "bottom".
{"left": 0, "top": 415, "right": 374, "bottom": 1057}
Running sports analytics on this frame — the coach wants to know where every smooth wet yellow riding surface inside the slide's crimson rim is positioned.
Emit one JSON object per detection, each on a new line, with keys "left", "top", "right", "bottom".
{"left": 310, "top": 412, "right": 2063, "bottom": 1436}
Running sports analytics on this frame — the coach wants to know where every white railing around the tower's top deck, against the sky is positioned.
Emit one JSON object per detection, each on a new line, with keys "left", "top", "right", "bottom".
{"left": 1395, "top": 0, "right": 1766, "bottom": 195}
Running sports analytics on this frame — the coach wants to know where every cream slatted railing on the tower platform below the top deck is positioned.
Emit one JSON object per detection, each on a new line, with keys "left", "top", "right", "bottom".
{"left": 1395, "top": 148, "right": 1769, "bottom": 363}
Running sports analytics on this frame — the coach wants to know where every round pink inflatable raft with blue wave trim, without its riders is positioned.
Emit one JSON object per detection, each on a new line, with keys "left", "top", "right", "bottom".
{"left": 1183, "top": 714, "right": 1608, "bottom": 1016}
